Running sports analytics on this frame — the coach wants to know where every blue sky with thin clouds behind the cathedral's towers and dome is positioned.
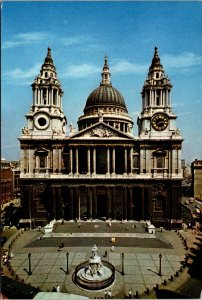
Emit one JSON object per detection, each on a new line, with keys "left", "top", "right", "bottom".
{"left": 1, "top": 1, "right": 202, "bottom": 163}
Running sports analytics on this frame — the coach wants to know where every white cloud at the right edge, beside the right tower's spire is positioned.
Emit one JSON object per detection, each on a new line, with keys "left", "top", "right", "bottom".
{"left": 162, "top": 52, "right": 202, "bottom": 69}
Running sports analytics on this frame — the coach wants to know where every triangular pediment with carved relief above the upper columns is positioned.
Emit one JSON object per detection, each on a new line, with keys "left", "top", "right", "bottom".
{"left": 67, "top": 122, "right": 133, "bottom": 139}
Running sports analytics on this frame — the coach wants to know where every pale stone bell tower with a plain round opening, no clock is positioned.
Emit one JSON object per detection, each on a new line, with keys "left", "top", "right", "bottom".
{"left": 22, "top": 48, "right": 67, "bottom": 139}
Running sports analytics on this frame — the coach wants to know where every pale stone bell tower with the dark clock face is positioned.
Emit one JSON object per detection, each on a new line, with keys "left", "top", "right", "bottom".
{"left": 138, "top": 47, "right": 179, "bottom": 139}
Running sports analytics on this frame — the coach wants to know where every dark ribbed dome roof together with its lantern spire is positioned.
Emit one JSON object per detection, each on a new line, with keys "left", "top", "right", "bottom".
{"left": 84, "top": 56, "right": 127, "bottom": 112}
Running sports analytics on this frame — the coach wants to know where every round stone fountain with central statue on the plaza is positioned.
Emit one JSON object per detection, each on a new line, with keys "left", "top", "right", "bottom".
{"left": 73, "top": 245, "right": 115, "bottom": 290}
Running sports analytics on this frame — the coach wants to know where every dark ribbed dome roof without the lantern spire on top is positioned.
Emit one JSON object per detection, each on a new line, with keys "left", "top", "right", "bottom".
{"left": 84, "top": 84, "right": 127, "bottom": 112}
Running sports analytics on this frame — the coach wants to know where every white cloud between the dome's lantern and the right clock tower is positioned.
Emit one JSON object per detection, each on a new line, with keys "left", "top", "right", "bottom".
{"left": 110, "top": 60, "right": 148, "bottom": 74}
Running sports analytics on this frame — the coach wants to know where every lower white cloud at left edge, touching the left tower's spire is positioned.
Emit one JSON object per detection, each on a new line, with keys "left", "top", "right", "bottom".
{"left": 4, "top": 64, "right": 41, "bottom": 79}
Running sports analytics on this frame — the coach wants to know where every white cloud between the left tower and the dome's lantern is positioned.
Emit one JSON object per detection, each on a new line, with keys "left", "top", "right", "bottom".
{"left": 60, "top": 64, "right": 100, "bottom": 78}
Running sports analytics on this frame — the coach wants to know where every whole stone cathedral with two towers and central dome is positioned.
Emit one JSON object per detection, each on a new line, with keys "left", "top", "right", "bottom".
{"left": 19, "top": 47, "right": 183, "bottom": 228}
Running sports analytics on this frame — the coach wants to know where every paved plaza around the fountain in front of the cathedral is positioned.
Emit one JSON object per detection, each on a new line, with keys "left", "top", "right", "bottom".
{"left": 2, "top": 222, "right": 201, "bottom": 298}
